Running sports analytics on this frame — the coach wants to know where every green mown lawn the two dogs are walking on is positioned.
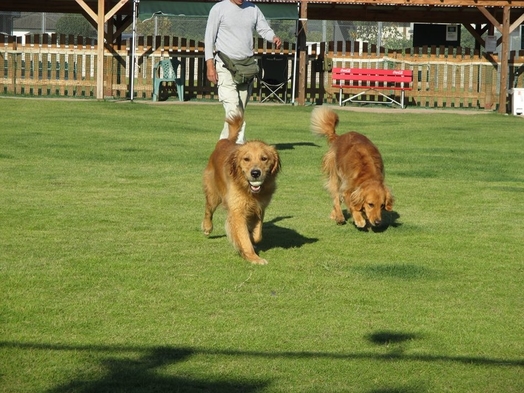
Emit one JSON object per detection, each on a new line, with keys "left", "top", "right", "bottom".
{"left": 0, "top": 98, "right": 524, "bottom": 393}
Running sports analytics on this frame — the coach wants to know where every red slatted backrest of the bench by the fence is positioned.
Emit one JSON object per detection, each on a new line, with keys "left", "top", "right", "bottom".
{"left": 332, "top": 68, "right": 413, "bottom": 86}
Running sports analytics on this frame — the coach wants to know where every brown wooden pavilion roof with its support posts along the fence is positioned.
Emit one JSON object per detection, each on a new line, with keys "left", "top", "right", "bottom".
{"left": 0, "top": 0, "right": 524, "bottom": 113}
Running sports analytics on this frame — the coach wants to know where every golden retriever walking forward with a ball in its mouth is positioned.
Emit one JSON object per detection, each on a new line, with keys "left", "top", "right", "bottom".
{"left": 202, "top": 114, "right": 280, "bottom": 265}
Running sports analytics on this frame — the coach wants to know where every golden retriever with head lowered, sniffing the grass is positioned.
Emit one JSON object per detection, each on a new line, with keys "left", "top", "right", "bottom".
{"left": 311, "top": 107, "right": 393, "bottom": 228}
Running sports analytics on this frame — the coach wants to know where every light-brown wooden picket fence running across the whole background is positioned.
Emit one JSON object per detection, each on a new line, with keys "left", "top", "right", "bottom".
{"left": 0, "top": 35, "right": 524, "bottom": 110}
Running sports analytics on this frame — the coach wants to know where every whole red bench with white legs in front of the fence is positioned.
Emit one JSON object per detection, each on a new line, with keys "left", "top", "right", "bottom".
{"left": 332, "top": 68, "right": 413, "bottom": 108}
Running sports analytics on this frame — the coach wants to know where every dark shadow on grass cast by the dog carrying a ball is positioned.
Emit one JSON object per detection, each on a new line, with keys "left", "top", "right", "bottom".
{"left": 257, "top": 216, "right": 318, "bottom": 251}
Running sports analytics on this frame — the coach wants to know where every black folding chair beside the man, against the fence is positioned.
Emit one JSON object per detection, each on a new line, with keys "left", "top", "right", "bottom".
{"left": 258, "top": 55, "right": 291, "bottom": 104}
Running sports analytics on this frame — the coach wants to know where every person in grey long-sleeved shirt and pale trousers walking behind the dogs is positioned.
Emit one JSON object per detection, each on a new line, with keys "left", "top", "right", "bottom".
{"left": 204, "top": 0, "right": 282, "bottom": 143}
